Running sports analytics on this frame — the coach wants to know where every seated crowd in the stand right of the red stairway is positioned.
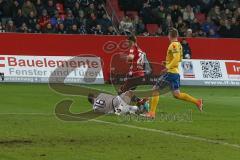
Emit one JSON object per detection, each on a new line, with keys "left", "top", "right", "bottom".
{"left": 120, "top": 0, "right": 240, "bottom": 38}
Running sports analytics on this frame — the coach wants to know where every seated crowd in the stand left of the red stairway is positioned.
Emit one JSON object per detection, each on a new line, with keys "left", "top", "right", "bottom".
{"left": 0, "top": 0, "right": 117, "bottom": 35}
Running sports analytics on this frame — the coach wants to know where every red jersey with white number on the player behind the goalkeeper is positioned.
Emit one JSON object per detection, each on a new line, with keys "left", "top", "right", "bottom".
{"left": 129, "top": 44, "right": 144, "bottom": 77}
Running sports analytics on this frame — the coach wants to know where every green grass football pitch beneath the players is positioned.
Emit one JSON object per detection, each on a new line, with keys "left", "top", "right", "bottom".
{"left": 0, "top": 83, "right": 240, "bottom": 160}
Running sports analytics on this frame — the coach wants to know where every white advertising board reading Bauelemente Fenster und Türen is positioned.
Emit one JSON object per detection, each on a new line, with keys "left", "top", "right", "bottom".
{"left": 0, "top": 55, "right": 104, "bottom": 84}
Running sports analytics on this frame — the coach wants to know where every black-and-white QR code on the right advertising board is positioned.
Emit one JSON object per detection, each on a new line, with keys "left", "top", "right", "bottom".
{"left": 200, "top": 61, "right": 223, "bottom": 79}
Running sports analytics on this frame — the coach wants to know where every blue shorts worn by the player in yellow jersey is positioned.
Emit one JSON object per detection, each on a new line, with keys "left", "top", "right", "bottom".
{"left": 155, "top": 73, "right": 180, "bottom": 91}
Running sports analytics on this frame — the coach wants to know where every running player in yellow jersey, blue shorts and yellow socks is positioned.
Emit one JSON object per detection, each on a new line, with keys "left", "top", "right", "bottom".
{"left": 146, "top": 28, "right": 203, "bottom": 118}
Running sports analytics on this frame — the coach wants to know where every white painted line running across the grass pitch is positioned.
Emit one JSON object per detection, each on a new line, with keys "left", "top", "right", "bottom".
{"left": 0, "top": 113, "right": 240, "bottom": 149}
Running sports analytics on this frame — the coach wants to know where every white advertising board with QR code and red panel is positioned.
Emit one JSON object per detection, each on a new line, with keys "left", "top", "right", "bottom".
{"left": 179, "top": 60, "right": 240, "bottom": 86}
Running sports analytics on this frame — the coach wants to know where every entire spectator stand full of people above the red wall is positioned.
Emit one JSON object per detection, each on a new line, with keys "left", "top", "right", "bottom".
{"left": 0, "top": 0, "right": 240, "bottom": 38}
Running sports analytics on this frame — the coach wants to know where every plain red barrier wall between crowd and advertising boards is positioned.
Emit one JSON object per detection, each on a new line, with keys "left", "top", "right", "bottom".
{"left": 0, "top": 33, "right": 240, "bottom": 80}
